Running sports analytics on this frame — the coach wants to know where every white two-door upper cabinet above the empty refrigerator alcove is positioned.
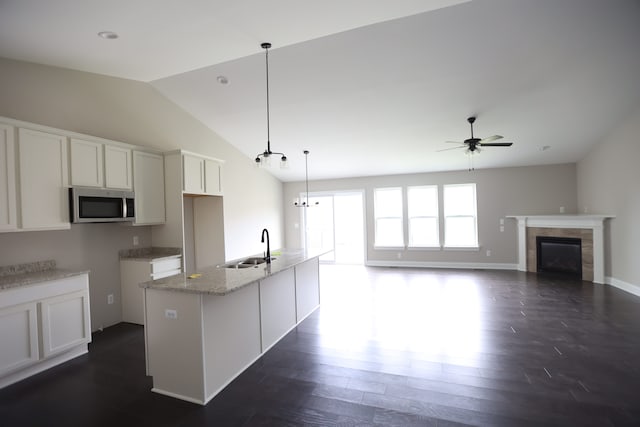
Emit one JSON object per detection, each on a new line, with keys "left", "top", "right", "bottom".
{"left": 182, "top": 154, "right": 222, "bottom": 196}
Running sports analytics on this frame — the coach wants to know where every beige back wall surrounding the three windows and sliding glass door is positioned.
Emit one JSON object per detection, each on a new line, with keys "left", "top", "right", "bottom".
{"left": 284, "top": 164, "right": 577, "bottom": 267}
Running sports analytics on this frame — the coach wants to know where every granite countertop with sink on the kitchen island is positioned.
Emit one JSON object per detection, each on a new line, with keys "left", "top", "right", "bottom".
{"left": 139, "top": 249, "right": 326, "bottom": 295}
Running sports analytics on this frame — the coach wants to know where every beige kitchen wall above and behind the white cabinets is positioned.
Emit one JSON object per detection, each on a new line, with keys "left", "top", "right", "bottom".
{"left": 0, "top": 58, "right": 284, "bottom": 329}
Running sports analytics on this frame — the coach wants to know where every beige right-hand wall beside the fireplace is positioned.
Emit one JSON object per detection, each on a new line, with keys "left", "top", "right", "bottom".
{"left": 577, "top": 109, "right": 640, "bottom": 295}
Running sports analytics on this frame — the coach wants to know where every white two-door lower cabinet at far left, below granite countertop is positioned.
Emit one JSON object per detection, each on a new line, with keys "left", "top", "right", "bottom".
{"left": 0, "top": 273, "right": 91, "bottom": 388}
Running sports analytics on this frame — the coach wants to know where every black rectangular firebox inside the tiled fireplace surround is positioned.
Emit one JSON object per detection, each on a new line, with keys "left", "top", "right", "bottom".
{"left": 536, "top": 236, "right": 582, "bottom": 279}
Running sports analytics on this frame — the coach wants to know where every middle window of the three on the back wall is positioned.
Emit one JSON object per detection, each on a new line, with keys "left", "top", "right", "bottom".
{"left": 407, "top": 185, "right": 440, "bottom": 247}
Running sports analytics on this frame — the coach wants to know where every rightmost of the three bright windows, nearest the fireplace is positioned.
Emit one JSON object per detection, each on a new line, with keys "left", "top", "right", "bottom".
{"left": 443, "top": 184, "right": 478, "bottom": 247}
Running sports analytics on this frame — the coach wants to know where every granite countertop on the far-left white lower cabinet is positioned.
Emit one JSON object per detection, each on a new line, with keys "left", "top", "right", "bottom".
{"left": 0, "top": 260, "right": 89, "bottom": 290}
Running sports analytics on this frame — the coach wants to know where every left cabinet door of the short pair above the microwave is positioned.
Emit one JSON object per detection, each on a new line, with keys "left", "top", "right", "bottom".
{"left": 69, "top": 138, "right": 104, "bottom": 187}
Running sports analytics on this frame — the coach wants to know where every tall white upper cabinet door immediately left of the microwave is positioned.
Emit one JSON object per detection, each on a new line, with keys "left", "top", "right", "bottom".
{"left": 18, "top": 128, "right": 71, "bottom": 230}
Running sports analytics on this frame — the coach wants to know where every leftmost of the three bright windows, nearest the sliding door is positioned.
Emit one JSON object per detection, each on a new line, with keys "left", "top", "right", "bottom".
{"left": 373, "top": 187, "right": 404, "bottom": 247}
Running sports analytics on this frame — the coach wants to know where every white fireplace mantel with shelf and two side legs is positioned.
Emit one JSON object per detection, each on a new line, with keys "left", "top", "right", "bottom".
{"left": 506, "top": 214, "right": 615, "bottom": 283}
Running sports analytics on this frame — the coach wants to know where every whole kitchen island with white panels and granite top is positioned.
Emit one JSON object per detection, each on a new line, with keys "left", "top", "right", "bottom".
{"left": 140, "top": 249, "right": 324, "bottom": 405}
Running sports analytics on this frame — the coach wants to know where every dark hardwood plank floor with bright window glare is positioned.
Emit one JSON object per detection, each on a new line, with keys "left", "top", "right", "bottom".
{"left": 0, "top": 265, "right": 640, "bottom": 427}
